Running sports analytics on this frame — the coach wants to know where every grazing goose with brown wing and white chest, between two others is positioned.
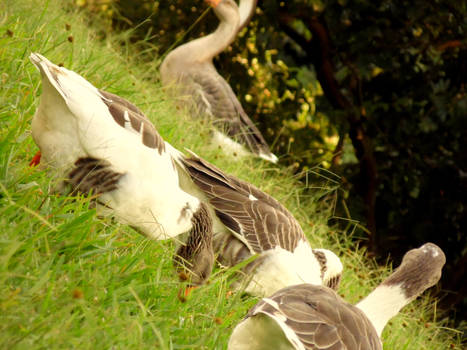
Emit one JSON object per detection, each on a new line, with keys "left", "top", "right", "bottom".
{"left": 180, "top": 153, "right": 342, "bottom": 296}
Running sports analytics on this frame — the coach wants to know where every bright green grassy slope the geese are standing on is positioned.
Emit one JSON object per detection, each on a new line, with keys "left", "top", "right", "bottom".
{"left": 0, "top": 0, "right": 460, "bottom": 350}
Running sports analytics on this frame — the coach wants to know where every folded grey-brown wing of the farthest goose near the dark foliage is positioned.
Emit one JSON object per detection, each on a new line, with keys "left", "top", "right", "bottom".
{"left": 187, "top": 69, "right": 275, "bottom": 159}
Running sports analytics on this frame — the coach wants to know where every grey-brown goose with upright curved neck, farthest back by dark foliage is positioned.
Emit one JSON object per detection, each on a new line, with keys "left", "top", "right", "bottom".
{"left": 160, "top": 0, "right": 278, "bottom": 163}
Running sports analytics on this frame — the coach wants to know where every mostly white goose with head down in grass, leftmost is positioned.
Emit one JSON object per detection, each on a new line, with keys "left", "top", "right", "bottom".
{"left": 30, "top": 53, "right": 214, "bottom": 282}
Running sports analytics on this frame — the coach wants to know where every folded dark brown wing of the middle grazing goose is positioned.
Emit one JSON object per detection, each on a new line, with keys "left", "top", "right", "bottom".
{"left": 182, "top": 155, "right": 305, "bottom": 253}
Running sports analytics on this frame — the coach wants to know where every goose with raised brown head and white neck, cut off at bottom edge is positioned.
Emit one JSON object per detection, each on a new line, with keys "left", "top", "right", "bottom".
{"left": 228, "top": 243, "right": 446, "bottom": 350}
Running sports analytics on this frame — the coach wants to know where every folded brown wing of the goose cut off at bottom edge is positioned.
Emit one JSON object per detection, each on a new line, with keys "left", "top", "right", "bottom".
{"left": 247, "top": 284, "right": 382, "bottom": 350}
